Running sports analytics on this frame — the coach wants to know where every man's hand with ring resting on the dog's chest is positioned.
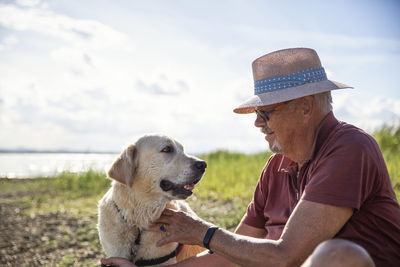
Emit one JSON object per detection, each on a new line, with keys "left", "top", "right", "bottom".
{"left": 147, "top": 209, "right": 211, "bottom": 246}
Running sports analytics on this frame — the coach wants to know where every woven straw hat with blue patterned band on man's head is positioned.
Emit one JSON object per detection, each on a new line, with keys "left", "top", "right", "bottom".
{"left": 233, "top": 48, "right": 353, "bottom": 114}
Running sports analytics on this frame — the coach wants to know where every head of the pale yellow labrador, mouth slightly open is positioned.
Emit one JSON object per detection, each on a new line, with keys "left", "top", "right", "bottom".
{"left": 108, "top": 135, "right": 207, "bottom": 199}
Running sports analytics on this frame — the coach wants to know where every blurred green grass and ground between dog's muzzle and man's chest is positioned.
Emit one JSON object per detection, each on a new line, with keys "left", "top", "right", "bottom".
{"left": 189, "top": 151, "right": 271, "bottom": 230}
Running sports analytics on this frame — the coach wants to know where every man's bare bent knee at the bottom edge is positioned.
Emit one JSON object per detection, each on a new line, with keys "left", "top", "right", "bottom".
{"left": 302, "top": 239, "right": 375, "bottom": 267}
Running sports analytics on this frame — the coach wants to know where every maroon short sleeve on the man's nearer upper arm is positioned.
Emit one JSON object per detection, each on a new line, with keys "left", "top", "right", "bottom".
{"left": 302, "top": 136, "right": 380, "bottom": 209}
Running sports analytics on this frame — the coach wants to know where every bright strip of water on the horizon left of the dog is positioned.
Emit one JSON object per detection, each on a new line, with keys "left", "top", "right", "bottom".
{"left": 0, "top": 153, "right": 117, "bottom": 178}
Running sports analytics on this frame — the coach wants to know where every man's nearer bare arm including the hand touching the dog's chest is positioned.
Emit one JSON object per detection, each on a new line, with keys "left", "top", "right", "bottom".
{"left": 158, "top": 200, "right": 353, "bottom": 266}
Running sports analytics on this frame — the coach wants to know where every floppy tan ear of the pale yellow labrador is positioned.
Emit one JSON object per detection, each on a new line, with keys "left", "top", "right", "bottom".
{"left": 108, "top": 145, "right": 138, "bottom": 187}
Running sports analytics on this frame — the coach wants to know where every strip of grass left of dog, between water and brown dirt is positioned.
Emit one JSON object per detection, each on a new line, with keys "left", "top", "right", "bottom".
{"left": 0, "top": 170, "right": 111, "bottom": 219}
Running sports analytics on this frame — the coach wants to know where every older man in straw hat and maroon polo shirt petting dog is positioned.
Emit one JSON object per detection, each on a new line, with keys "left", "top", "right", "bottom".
{"left": 103, "top": 48, "right": 400, "bottom": 267}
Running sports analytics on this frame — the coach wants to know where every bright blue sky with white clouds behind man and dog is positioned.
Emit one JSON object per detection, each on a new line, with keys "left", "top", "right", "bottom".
{"left": 0, "top": 0, "right": 400, "bottom": 153}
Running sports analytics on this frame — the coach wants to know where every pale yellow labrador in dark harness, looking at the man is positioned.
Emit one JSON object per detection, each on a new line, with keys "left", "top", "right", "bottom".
{"left": 98, "top": 135, "right": 207, "bottom": 266}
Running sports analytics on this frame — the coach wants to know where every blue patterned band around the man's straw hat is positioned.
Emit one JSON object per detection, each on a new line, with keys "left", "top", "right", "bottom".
{"left": 254, "top": 67, "right": 328, "bottom": 95}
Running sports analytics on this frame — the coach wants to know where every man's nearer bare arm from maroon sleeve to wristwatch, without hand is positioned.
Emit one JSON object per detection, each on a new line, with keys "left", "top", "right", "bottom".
{"left": 205, "top": 200, "right": 353, "bottom": 266}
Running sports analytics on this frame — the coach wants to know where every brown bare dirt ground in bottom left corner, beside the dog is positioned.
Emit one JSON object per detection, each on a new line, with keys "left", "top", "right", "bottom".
{"left": 0, "top": 194, "right": 103, "bottom": 266}
